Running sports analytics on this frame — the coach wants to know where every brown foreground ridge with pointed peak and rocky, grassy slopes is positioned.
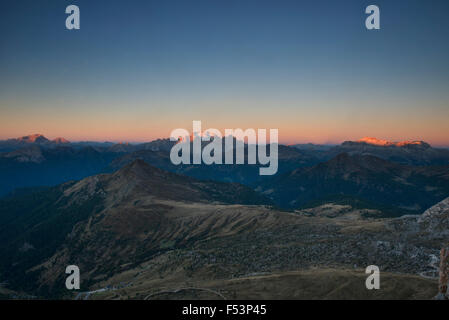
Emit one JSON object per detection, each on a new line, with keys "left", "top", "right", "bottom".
{"left": 0, "top": 159, "right": 447, "bottom": 299}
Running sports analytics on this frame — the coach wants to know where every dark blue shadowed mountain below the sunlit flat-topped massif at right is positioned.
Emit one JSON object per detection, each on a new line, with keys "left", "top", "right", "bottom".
{"left": 261, "top": 153, "right": 449, "bottom": 214}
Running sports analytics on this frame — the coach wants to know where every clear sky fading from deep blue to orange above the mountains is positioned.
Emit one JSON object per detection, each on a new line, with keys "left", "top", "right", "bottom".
{"left": 0, "top": 0, "right": 449, "bottom": 146}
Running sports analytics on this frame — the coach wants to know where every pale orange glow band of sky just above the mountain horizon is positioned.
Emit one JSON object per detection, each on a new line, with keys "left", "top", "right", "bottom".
{"left": 0, "top": 103, "right": 449, "bottom": 147}
